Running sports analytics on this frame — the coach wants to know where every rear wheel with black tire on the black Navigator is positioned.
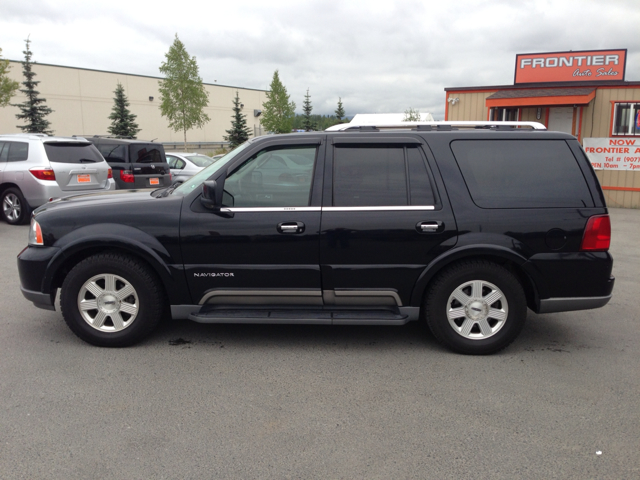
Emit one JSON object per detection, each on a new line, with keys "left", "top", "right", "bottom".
{"left": 424, "top": 260, "right": 527, "bottom": 355}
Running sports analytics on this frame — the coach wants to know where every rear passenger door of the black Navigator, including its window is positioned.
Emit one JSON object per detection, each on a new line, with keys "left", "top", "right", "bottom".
{"left": 320, "top": 134, "right": 457, "bottom": 306}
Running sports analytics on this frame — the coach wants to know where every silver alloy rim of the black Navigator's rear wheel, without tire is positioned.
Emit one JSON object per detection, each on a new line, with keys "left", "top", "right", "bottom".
{"left": 447, "top": 280, "right": 509, "bottom": 340}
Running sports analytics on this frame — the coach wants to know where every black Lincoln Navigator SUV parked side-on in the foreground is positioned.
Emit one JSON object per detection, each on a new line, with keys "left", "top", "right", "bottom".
{"left": 18, "top": 122, "right": 614, "bottom": 354}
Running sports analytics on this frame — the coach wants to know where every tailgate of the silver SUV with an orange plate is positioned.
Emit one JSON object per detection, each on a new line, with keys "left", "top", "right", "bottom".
{"left": 44, "top": 142, "right": 109, "bottom": 192}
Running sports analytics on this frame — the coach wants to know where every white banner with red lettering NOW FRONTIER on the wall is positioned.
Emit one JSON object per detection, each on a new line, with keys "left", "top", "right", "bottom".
{"left": 584, "top": 137, "right": 640, "bottom": 170}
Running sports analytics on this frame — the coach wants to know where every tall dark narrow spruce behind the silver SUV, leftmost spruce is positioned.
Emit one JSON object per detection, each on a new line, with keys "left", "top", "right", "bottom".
{"left": 12, "top": 38, "right": 53, "bottom": 135}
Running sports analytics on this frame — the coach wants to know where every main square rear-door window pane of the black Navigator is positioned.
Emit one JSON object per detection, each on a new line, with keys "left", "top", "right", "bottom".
{"left": 333, "top": 146, "right": 407, "bottom": 207}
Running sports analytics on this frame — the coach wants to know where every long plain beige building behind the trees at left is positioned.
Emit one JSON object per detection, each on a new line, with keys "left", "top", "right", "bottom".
{"left": 0, "top": 61, "right": 266, "bottom": 150}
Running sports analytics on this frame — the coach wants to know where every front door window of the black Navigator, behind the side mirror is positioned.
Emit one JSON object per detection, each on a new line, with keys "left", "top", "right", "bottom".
{"left": 222, "top": 147, "right": 316, "bottom": 207}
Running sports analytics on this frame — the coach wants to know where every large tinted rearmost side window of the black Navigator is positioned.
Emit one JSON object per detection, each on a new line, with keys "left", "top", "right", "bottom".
{"left": 451, "top": 140, "right": 593, "bottom": 208}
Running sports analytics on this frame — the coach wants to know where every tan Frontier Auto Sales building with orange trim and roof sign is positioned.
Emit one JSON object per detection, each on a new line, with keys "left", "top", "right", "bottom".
{"left": 445, "top": 50, "right": 640, "bottom": 208}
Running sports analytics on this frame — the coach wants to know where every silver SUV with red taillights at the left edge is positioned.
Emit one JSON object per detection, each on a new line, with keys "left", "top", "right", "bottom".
{"left": 0, "top": 134, "right": 116, "bottom": 225}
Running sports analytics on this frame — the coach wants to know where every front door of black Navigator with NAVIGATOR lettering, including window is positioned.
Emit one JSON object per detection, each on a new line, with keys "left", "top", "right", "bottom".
{"left": 180, "top": 140, "right": 324, "bottom": 306}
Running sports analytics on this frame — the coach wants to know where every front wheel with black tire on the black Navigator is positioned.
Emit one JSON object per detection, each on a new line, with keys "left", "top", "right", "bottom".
{"left": 60, "top": 253, "right": 166, "bottom": 347}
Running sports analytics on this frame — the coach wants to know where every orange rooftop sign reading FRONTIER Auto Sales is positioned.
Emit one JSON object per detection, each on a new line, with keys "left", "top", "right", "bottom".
{"left": 514, "top": 50, "right": 627, "bottom": 83}
